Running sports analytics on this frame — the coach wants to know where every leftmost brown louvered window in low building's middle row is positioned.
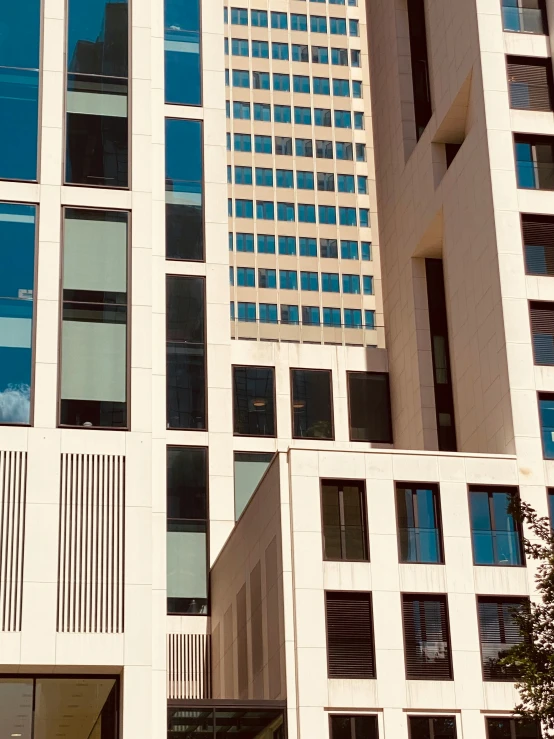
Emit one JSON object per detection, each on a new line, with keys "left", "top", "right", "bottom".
{"left": 326, "top": 592, "right": 375, "bottom": 679}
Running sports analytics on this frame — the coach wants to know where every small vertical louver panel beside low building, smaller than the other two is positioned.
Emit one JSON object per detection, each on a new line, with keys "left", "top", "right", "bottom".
{"left": 167, "top": 634, "right": 212, "bottom": 700}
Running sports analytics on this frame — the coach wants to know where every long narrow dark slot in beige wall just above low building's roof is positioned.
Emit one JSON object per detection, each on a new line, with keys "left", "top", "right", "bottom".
{"left": 425, "top": 259, "right": 457, "bottom": 452}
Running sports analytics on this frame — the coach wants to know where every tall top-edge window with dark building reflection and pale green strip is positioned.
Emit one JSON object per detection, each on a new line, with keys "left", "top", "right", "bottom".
{"left": 65, "top": 0, "right": 129, "bottom": 187}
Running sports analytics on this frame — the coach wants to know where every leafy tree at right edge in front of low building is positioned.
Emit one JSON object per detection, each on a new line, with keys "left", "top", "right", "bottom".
{"left": 501, "top": 500, "right": 554, "bottom": 739}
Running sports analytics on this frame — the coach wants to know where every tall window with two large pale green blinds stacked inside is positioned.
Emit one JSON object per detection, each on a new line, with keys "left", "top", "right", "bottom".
{"left": 60, "top": 208, "right": 128, "bottom": 428}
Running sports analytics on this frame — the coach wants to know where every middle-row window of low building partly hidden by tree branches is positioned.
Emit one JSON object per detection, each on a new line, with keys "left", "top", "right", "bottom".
{"left": 478, "top": 598, "right": 526, "bottom": 681}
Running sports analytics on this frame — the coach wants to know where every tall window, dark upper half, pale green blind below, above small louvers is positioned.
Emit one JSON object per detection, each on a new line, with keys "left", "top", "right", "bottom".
{"left": 167, "top": 446, "right": 208, "bottom": 615}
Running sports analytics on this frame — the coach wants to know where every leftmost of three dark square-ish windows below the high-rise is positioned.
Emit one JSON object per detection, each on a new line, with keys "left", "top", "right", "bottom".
{"left": 233, "top": 367, "right": 275, "bottom": 436}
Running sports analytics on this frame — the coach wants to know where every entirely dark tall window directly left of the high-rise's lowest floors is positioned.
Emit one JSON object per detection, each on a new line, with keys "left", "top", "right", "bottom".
{"left": 166, "top": 275, "right": 206, "bottom": 429}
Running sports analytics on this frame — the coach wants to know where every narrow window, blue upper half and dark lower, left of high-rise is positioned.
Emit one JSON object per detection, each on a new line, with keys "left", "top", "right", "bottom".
{"left": 165, "top": 118, "right": 204, "bottom": 262}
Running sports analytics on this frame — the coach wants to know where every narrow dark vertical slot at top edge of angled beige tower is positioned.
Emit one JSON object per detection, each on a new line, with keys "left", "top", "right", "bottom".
{"left": 408, "top": 0, "right": 433, "bottom": 140}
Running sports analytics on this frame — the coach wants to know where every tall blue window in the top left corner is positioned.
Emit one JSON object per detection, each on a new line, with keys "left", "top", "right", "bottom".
{"left": 0, "top": 0, "right": 41, "bottom": 180}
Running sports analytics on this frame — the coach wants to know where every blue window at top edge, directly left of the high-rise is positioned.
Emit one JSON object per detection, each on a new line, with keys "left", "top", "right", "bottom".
{"left": 165, "top": 0, "right": 202, "bottom": 105}
